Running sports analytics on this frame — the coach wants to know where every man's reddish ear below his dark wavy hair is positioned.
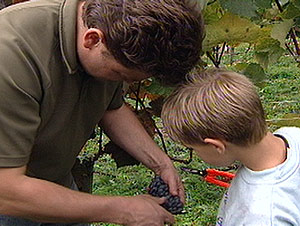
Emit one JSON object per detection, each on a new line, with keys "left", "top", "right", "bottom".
{"left": 83, "top": 28, "right": 104, "bottom": 49}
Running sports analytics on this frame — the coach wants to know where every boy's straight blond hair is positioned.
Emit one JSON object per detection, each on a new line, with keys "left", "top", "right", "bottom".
{"left": 162, "top": 69, "right": 267, "bottom": 145}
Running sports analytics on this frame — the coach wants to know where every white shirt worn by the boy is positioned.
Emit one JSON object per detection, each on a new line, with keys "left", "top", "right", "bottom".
{"left": 217, "top": 158, "right": 300, "bottom": 225}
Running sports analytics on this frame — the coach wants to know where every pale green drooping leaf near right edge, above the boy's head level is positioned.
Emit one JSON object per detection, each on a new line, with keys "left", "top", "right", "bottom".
{"left": 271, "top": 20, "right": 294, "bottom": 48}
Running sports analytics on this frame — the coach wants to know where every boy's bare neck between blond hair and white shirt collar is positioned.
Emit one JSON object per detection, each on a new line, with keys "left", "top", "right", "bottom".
{"left": 239, "top": 132, "right": 287, "bottom": 171}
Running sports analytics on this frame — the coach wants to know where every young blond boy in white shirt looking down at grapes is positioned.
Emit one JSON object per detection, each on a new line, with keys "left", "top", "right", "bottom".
{"left": 162, "top": 70, "right": 300, "bottom": 226}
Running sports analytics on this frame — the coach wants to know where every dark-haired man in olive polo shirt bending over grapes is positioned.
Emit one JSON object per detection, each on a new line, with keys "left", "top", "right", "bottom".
{"left": 0, "top": 0, "right": 203, "bottom": 226}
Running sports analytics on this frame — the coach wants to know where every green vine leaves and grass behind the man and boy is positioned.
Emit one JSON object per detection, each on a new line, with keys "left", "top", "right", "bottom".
{"left": 83, "top": 0, "right": 300, "bottom": 226}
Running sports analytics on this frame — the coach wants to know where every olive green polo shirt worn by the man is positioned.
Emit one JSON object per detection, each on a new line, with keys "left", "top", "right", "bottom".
{"left": 0, "top": 0, "right": 122, "bottom": 186}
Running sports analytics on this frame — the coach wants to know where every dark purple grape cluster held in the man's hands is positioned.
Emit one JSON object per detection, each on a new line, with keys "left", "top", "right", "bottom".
{"left": 148, "top": 176, "right": 183, "bottom": 214}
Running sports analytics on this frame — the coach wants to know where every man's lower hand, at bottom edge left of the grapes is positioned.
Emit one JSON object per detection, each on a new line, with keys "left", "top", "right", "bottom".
{"left": 125, "top": 195, "right": 174, "bottom": 226}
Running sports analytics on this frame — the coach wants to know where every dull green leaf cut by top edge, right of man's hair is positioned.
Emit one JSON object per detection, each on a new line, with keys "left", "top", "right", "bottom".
{"left": 220, "top": 0, "right": 257, "bottom": 18}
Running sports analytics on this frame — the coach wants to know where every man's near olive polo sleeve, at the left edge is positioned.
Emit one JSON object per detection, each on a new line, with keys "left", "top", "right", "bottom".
{"left": 0, "top": 39, "right": 42, "bottom": 167}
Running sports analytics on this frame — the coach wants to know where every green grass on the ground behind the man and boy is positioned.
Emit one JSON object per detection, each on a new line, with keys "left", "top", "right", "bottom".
{"left": 82, "top": 48, "right": 300, "bottom": 226}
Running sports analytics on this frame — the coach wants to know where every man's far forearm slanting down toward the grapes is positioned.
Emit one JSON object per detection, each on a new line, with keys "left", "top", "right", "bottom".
{"left": 100, "top": 105, "right": 172, "bottom": 172}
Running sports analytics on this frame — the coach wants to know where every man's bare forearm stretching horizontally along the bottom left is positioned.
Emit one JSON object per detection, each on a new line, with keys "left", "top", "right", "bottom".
{"left": 0, "top": 168, "right": 128, "bottom": 223}
